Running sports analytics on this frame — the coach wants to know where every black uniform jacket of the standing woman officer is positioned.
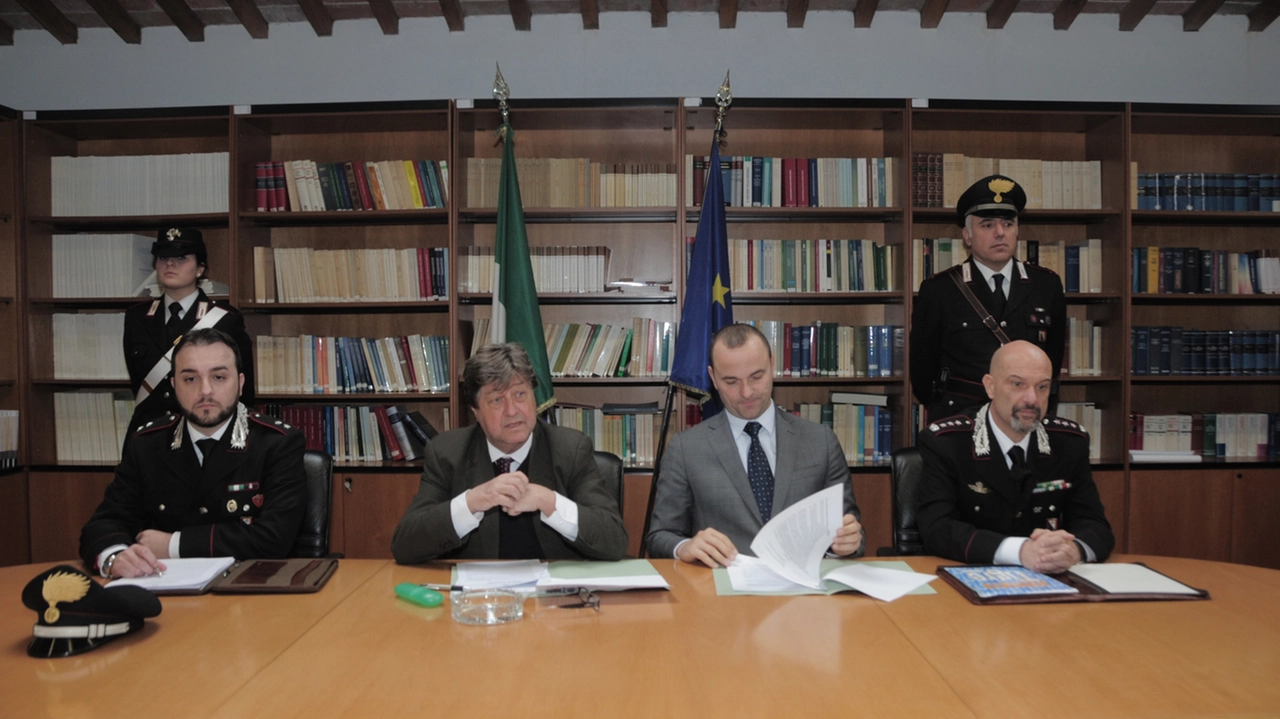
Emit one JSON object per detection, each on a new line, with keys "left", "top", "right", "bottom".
{"left": 124, "top": 289, "right": 253, "bottom": 431}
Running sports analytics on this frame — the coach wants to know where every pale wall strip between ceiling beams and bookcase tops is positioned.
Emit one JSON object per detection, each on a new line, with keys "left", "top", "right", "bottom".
{"left": 0, "top": 12, "right": 1280, "bottom": 110}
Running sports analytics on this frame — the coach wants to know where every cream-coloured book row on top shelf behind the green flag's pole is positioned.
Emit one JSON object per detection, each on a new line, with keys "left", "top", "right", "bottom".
{"left": 467, "top": 157, "right": 676, "bottom": 209}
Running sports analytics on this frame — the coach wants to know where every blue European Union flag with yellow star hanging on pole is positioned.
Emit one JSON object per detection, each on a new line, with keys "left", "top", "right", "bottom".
{"left": 669, "top": 138, "right": 733, "bottom": 418}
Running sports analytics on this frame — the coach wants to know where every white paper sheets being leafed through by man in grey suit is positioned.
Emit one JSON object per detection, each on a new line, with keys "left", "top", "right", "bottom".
{"left": 716, "top": 485, "right": 936, "bottom": 601}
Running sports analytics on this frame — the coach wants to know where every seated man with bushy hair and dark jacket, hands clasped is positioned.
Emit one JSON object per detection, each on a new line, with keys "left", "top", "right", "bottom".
{"left": 392, "top": 343, "right": 627, "bottom": 564}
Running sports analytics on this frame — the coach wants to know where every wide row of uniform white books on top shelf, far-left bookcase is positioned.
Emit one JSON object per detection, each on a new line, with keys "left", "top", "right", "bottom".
{"left": 50, "top": 152, "right": 229, "bottom": 217}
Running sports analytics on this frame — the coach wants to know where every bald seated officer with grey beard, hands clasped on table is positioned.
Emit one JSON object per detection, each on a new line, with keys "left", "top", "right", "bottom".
{"left": 916, "top": 340, "right": 1115, "bottom": 573}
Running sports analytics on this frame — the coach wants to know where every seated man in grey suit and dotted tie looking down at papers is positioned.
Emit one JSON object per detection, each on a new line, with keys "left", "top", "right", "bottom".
{"left": 645, "top": 325, "right": 864, "bottom": 567}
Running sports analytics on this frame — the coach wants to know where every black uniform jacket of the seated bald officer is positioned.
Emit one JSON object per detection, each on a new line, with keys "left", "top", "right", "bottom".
{"left": 916, "top": 406, "right": 1115, "bottom": 564}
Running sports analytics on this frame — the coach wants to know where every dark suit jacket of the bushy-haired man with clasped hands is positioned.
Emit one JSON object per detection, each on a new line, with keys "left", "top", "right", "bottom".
{"left": 392, "top": 422, "right": 627, "bottom": 564}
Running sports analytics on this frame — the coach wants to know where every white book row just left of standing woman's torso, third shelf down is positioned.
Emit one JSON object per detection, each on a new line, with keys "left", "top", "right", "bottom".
{"left": 54, "top": 312, "right": 129, "bottom": 380}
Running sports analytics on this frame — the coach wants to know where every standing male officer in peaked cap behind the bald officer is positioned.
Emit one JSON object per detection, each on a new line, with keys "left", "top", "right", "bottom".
{"left": 911, "top": 175, "right": 1066, "bottom": 421}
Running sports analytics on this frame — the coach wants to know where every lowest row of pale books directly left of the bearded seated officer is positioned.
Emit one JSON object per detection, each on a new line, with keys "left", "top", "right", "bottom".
{"left": 54, "top": 391, "right": 133, "bottom": 464}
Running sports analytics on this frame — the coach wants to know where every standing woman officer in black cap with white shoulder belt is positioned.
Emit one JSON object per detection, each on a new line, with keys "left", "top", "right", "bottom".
{"left": 124, "top": 228, "right": 253, "bottom": 435}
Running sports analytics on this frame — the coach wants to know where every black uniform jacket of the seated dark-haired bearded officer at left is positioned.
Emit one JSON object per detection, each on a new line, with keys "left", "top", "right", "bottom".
{"left": 79, "top": 407, "right": 306, "bottom": 567}
